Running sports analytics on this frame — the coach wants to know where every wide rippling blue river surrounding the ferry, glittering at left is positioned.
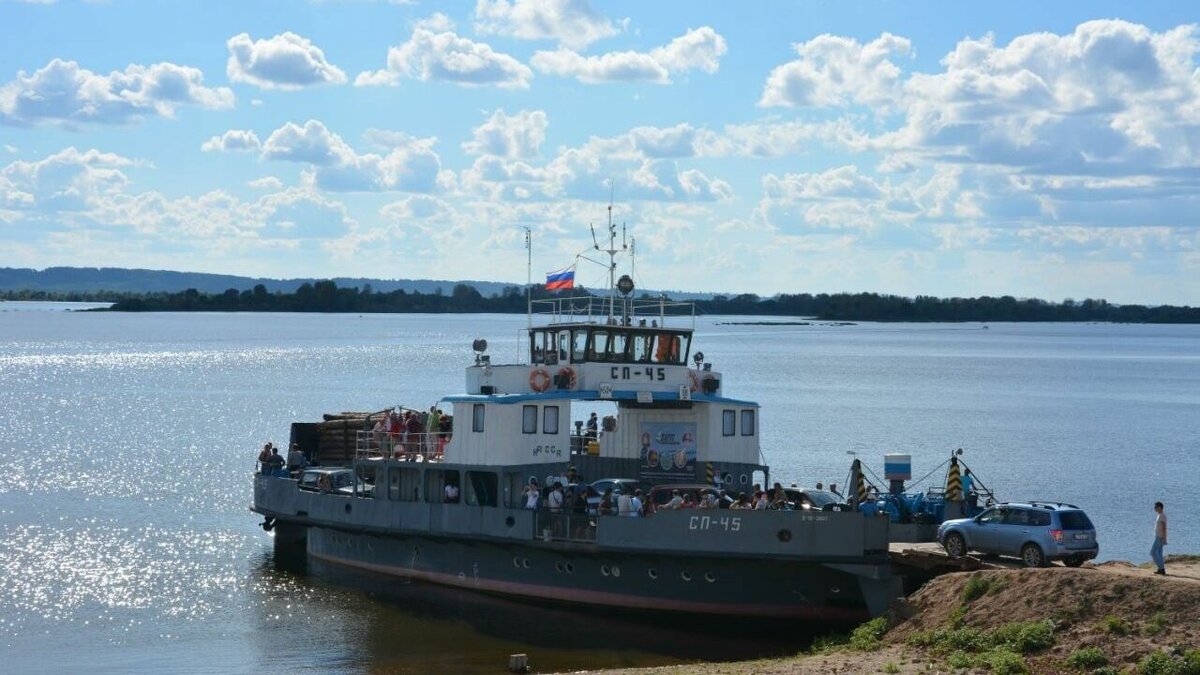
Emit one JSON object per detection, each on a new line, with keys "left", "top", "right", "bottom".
{"left": 0, "top": 303, "right": 1200, "bottom": 673}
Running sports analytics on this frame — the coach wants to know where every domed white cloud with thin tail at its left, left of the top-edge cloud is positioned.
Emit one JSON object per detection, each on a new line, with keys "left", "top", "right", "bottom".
{"left": 354, "top": 28, "right": 533, "bottom": 89}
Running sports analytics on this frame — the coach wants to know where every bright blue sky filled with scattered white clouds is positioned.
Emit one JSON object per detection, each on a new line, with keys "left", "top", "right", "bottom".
{"left": 0, "top": 0, "right": 1200, "bottom": 305}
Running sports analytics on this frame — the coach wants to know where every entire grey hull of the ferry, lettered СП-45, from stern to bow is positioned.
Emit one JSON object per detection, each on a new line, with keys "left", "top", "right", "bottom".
{"left": 253, "top": 468, "right": 900, "bottom": 622}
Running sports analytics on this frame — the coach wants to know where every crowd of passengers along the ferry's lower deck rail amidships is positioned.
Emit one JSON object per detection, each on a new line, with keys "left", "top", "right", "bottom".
{"left": 521, "top": 466, "right": 841, "bottom": 518}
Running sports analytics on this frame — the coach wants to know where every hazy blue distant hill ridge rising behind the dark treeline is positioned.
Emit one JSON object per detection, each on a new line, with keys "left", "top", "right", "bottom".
{"left": 0, "top": 267, "right": 712, "bottom": 299}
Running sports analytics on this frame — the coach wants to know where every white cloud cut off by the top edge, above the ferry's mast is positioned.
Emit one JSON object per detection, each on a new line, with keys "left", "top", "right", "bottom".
{"left": 475, "top": 0, "right": 619, "bottom": 49}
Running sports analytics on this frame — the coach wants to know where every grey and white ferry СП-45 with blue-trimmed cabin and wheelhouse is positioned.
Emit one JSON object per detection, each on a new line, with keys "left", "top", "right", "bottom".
{"left": 252, "top": 227, "right": 901, "bottom": 623}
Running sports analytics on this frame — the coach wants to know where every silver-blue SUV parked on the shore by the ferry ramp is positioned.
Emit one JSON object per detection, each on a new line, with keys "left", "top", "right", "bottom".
{"left": 937, "top": 502, "right": 1100, "bottom": 567}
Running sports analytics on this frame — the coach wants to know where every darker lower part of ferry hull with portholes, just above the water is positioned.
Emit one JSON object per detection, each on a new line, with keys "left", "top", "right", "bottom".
{"left": 307, "top": 527, "right": 881, "bottom": 622}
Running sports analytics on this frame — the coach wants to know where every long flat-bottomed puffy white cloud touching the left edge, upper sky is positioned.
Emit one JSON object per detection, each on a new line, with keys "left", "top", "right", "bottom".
{"left": 0, "top": 59, "right": 234, "bottom": 126}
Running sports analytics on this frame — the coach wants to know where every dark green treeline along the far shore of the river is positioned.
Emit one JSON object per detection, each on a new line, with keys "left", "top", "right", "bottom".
{"left": 0, "top": 281, "right": 1185, "bottom": 323}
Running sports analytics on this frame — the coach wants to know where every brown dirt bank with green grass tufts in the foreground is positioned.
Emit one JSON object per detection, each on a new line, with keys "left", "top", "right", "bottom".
{"left": 566, "top": 556, "right": 1200, "bottom": 675}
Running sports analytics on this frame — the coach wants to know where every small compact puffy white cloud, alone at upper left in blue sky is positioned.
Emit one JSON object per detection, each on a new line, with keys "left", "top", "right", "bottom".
{"left": 226, "top": 32, "right": 346, "bottom": 89}
